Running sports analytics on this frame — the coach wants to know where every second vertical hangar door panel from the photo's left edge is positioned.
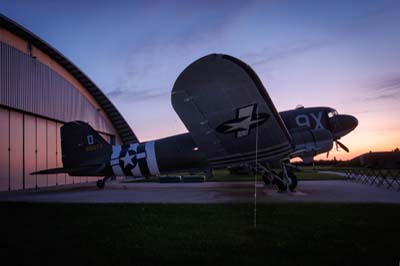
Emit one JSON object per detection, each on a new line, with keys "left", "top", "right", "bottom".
{"left": 10, "top": 111, "right": 24, "bottom": 190}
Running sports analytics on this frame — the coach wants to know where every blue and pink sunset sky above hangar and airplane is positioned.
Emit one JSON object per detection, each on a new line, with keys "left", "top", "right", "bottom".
{"left": 0, "top": 0, "right": 400, "bottom": 159}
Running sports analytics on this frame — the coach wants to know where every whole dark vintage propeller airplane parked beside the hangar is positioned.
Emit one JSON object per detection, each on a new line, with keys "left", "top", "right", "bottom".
{"left": 31, "top": 54, "right": 358, "bottom": 191}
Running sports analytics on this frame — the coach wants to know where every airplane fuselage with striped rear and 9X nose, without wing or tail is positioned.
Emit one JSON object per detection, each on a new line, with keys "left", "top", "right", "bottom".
{"left": 75, "top": 107, "right": 357, "bottom": 177}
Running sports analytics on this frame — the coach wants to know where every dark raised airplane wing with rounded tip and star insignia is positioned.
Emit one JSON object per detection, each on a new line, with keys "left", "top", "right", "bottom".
{"left": 171, "top": 54, "right": 293, "bottom": 167}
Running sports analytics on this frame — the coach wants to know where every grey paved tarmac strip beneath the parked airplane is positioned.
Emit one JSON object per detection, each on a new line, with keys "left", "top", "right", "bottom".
{"left": 0, "top": 180, "right": 400, "bottom": 204}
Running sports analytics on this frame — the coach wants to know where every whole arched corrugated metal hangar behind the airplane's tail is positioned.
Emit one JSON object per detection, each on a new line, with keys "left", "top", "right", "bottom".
{"left": 0, "top": 14, "right": 137, "bottom": 191}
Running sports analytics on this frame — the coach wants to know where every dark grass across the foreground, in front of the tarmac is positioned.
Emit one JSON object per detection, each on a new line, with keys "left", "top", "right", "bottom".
{"left": 0, "top": 203, "right": 400, "bottom": 265}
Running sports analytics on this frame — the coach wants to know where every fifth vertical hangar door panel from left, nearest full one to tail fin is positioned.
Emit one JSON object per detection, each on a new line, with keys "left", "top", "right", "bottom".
{"left": 47, "top": 120, "right": 57, "bottom": 186}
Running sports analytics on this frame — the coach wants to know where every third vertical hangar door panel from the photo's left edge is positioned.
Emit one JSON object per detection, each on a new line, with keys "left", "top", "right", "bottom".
{"left": 24, "top": 115, "right": 36, "bottom": 188}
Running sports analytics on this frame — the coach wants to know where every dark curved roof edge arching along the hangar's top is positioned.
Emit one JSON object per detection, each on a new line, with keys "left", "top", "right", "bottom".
{"left": 0, "top": 14, "right": 138, "bottom": 143}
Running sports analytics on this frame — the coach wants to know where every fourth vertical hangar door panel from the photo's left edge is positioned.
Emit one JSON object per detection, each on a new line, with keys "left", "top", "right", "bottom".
{"left": 36, "top": 117, "right": 47, "bottom": 187}
